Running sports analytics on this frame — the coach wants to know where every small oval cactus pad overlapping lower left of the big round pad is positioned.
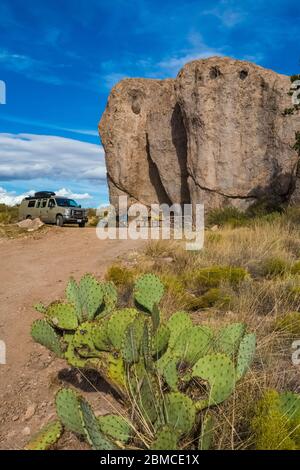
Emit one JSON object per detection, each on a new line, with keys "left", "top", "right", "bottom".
{"left": 164, "top": 392, "right": 196, "bottom": 435}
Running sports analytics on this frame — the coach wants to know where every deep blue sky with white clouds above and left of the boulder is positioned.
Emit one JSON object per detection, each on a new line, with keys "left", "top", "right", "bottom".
{"left": 0, "top": 0, "right": 300, "bottom": 207}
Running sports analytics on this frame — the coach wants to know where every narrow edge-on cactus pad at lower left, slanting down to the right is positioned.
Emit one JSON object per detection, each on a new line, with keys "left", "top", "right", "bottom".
{"left": 80, "top": 397, "right": 117, "bottom": 450}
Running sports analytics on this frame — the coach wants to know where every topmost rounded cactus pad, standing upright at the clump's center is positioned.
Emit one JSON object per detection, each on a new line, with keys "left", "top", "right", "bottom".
{"left": 134, "top": 274, "right": 164, "bottom": 313}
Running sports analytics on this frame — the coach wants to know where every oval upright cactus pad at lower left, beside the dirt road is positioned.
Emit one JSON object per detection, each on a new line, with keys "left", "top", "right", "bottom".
{"left": 55, "top": 388, "right": 85, "bottom": 436}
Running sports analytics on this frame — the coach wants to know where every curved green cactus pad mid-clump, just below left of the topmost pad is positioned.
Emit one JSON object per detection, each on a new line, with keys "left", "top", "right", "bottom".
{"left": 107, "top": 308, "right": 138, "bottom": 351}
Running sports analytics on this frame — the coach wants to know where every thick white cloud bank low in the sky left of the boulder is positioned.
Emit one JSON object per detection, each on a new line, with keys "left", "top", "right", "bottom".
{"left": 0, "top": 133, "right": 106, "bottom": 182}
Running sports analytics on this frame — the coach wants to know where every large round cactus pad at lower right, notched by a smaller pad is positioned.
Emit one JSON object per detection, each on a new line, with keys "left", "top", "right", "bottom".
{"left": 193, "top": 353, "right": 235, "bottom": 410}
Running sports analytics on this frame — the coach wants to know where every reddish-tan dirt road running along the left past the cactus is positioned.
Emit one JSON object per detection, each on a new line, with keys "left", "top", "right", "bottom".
{"left": 0, "top": 227, "right": 141, "bottom": 449}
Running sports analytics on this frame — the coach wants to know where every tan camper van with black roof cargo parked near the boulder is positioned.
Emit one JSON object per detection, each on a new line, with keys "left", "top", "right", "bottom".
{"left": 19, "top": 191, "right": 88, "bottom": 227}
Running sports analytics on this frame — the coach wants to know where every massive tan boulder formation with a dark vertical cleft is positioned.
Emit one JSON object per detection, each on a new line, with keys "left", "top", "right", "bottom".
{"left": 99, "top": 57, "right": 300, "bottom": 209}
